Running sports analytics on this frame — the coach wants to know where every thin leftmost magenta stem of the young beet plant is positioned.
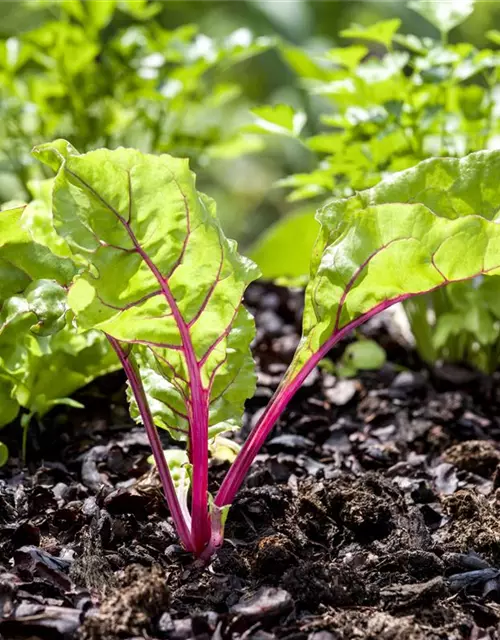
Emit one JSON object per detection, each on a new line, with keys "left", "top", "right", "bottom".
{"left": 106, "top": 335, "right": 193, "bottom": 551}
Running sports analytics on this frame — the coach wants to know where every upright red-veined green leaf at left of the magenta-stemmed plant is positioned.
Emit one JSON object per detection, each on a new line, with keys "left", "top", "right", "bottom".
{"left": 35, "top": 141, "right": 258, "bottom": 438}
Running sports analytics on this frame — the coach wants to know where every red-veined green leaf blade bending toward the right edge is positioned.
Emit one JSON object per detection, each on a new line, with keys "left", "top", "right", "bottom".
{"left": 289, "top": 151, "right": 500, "bottom": 378}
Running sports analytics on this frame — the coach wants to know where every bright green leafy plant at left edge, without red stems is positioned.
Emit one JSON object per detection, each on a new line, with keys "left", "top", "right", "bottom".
{"left": 0, "top": 195, "right": 119, "bottom": 463}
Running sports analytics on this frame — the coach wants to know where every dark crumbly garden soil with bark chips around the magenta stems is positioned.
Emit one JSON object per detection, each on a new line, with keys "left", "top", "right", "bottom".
{"left": 0, "top": 285, "right": 500, "bottom": 640}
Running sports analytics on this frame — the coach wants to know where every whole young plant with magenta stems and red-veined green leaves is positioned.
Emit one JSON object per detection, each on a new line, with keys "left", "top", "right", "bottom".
{"left": 34, "top": 140, "right": 500, "bottom": 559}
